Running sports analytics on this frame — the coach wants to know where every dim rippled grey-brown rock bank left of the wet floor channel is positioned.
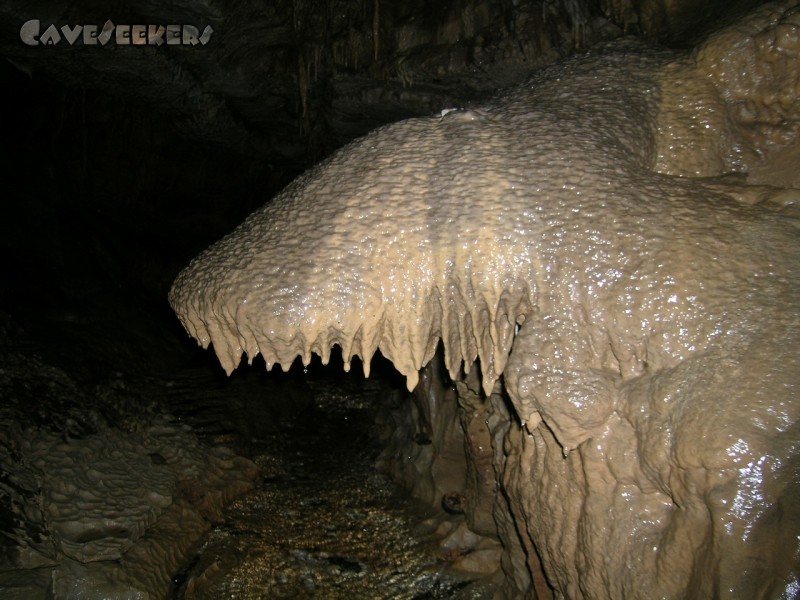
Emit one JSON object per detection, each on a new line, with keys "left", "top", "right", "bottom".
{"left": 0, "top": 350, "right": 256, "bottom": 598}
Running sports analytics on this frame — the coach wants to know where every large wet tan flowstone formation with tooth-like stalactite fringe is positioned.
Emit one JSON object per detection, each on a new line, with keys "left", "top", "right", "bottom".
{"left": 170, "top": 2, "right": 800, "bottom": 598}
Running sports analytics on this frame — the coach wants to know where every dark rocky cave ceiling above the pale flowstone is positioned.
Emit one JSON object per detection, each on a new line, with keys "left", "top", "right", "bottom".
{"left": 0, "top": 0, "right": 754, "bottom": 170}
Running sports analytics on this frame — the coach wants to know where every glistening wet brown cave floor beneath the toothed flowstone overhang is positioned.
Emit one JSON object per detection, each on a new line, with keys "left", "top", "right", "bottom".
{"left": 168, "top": 364, "right": 494, "bottom": 600}
